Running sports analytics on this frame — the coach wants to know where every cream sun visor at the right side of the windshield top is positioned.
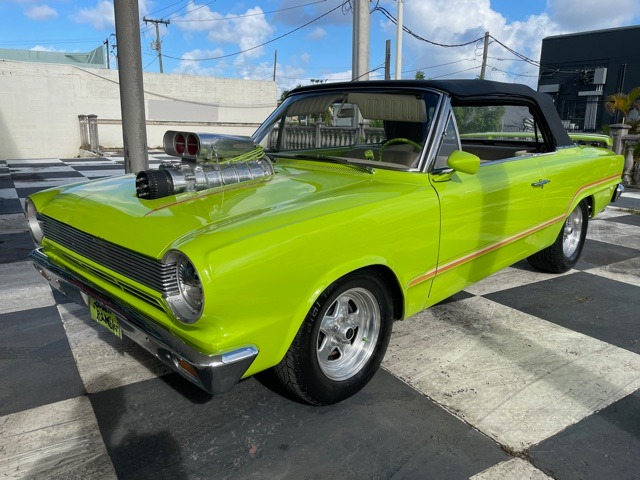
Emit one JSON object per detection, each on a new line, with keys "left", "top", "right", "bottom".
{"left": 347, "top": 93, "right": 427, "bottom": 123}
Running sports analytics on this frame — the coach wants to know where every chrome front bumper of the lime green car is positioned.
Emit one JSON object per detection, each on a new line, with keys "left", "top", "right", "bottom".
{"left": 29, "top": 249, "right": 258, "bottom": 394}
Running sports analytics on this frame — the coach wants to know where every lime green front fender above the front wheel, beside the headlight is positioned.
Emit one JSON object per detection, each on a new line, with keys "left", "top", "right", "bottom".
{"left": 169, "top": 189, "right": 439, "bottom": 376}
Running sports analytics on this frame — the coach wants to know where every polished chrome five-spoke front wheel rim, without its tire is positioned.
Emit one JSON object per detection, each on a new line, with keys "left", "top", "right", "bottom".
{"left": 316, "top": 288, "right": 381, "bottom": 381}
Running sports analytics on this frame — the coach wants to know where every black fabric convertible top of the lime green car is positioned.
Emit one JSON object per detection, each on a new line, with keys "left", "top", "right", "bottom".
{"left": 290, "top": 80, "right": 573, "bottom": 147}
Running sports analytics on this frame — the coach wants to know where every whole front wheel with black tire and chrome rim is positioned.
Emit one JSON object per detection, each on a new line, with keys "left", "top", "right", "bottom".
{"left": 275, "top": 271, "right": 393, "bottom": 405}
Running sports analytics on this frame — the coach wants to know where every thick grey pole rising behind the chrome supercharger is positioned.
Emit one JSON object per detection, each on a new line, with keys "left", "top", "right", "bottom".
{"left": 113, "top": 0, "right": 149, "bottom": 173}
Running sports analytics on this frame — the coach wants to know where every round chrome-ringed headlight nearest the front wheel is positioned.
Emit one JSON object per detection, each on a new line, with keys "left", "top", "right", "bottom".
{"left": 164, "top": 250, "right": 204, "bottom": 323}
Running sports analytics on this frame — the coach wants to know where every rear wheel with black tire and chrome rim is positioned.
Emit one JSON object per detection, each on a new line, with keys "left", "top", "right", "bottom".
{"left": 527, "top": 200, "right": 589, "bottom": 273}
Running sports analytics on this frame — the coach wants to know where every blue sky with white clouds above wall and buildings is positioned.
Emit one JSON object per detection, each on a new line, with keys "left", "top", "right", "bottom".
{"left": 0, "top": 0, "right": 640, "bottom": 93}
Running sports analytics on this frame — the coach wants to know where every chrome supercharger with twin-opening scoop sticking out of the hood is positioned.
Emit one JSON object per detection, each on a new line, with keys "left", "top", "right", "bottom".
{"left": 136, "top": 130, "right": 274, "bottom": 199}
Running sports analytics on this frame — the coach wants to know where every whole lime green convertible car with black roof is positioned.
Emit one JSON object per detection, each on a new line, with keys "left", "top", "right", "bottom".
{"left": 26, "top": 80, "right": 623, "bottom": 405}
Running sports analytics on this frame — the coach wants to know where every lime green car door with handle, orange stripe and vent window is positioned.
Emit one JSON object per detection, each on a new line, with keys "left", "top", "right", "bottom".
{"left": 426, "top": 110, "right": 544, "bottom": 306}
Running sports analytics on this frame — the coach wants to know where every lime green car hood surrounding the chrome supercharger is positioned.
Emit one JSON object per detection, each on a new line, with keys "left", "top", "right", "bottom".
{"left": 36, "top": 161, "right": 416, "bottom": 258}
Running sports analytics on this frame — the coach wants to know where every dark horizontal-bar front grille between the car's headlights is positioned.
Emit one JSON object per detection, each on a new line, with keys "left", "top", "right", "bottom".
{"left": 39, "top": 215, "right": 178, "bottom": 295}
